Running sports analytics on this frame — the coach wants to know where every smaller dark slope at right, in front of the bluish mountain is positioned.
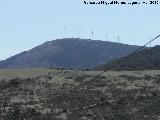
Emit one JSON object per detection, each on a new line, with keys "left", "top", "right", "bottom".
{"left": 98, "top": 46, "right": 160, "bottom": 70}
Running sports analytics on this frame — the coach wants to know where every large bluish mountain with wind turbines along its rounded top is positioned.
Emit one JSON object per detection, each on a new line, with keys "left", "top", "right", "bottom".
{"left": 0, "top": 38, "right": 139, "bottom": 69}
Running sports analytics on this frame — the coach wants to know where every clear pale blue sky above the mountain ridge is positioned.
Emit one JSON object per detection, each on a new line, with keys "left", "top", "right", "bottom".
{"left": 0, "top": 0, "right": 160, "bottom": 60}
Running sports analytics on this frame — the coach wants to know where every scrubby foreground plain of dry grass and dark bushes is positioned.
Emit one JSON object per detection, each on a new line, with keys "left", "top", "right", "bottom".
{"left": 0, "top": 68, "right": 160, "bottom": 120}
